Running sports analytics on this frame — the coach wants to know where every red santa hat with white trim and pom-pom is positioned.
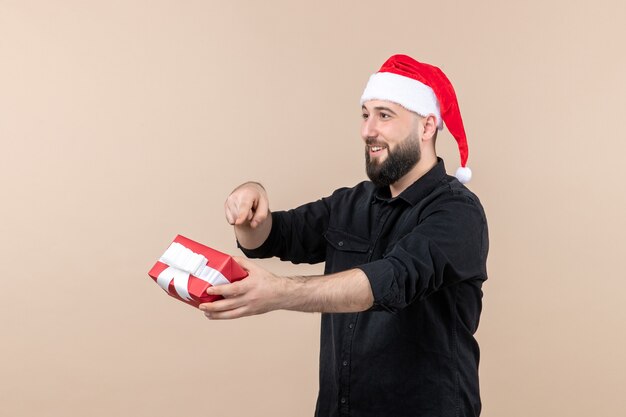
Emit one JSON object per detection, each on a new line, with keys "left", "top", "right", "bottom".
{"left": 361, "top": 55, "right": 472, "bottom": 183}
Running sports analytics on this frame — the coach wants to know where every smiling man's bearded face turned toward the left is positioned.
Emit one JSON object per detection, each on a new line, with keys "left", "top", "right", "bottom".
{"left": 361, "top": 100, "right": 421, "bottom": 186}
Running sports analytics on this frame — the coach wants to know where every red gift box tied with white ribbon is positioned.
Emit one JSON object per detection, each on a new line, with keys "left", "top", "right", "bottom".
{"left": 148, "top": 235, "right": 248, "bottom": 307}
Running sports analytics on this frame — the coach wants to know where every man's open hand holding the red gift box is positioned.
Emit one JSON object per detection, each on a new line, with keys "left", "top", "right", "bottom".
{"left": 200, "top": 257, "right": 288, "bottom": 319}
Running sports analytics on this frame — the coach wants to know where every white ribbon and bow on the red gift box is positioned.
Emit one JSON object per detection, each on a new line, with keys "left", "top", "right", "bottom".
{"left": 157, "top": 242, "right": 230, "bottom": 301}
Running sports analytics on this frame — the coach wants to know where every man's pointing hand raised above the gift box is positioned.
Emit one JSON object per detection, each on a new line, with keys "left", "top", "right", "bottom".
{"left": 224, "top": 182, "right": 269, "bottom": 229}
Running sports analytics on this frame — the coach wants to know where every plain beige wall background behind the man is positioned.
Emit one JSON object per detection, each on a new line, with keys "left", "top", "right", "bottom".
{"left": 0, "top": 0, "right": 626, "bottom": 417}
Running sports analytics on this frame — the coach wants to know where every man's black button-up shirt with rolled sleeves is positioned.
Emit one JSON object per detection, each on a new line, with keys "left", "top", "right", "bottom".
{"left": 242, "top": 160, "right": 488, "bottom": 417}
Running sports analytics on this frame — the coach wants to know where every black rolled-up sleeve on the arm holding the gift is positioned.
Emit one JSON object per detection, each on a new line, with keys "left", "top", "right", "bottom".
{"left": 358, "top": 195, "right": 488, "bottom": 310}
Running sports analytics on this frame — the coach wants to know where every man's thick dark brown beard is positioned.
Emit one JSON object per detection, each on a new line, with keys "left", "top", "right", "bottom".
{"left": 365, "top": 133, "right": 422, "bottom": 187}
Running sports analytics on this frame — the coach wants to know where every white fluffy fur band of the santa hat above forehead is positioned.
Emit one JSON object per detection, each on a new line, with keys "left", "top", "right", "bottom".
{"left": 361, "top": 72, "right": 443, "bottom": 130}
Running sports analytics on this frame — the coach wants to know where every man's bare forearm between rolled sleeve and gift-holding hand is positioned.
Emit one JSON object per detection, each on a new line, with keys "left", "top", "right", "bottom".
{"left": 282, "top": 269, "right": 374, "bottom": 313}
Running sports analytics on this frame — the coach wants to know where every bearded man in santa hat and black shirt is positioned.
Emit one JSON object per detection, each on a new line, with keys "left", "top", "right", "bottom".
{"left": 201, "top": 55, "right": 488, "bottom": 417}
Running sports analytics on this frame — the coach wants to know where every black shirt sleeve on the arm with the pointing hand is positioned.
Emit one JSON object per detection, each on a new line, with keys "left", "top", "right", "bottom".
{"left": 237, "top": 198, "right": 330, "bottom": 264}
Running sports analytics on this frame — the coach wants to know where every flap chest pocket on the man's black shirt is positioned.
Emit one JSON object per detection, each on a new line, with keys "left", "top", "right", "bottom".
{"left": 324, "top": 229, "right": 371, "bottom": 274}
